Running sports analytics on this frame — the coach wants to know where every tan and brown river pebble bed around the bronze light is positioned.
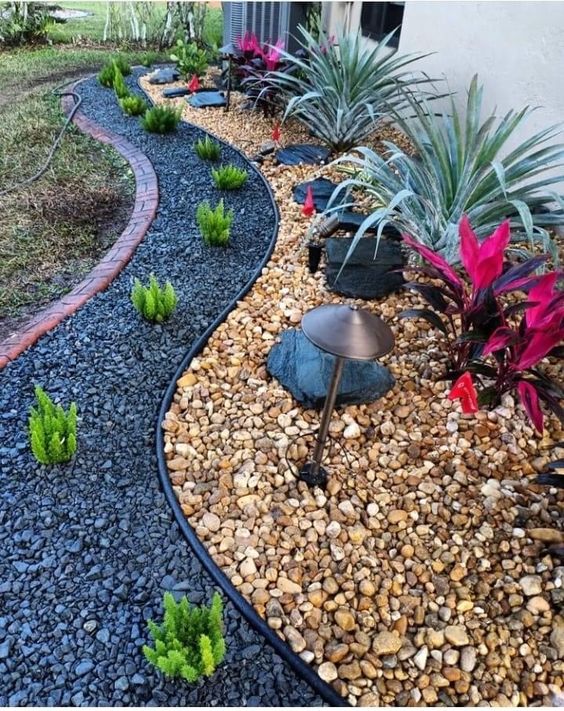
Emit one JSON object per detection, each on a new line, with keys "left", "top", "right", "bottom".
{"left": 151, "top": 72, "right": 564, "bottom": 705}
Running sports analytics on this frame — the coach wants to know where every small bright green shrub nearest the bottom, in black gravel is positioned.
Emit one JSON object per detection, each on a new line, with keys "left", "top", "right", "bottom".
{"left": 143, "top": 592, "right": 225, "bottom": 684}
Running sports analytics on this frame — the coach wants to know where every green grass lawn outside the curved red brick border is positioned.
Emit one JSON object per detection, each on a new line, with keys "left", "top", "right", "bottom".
{"left": 0, "top": 2, "right": 222, "bottom": 340}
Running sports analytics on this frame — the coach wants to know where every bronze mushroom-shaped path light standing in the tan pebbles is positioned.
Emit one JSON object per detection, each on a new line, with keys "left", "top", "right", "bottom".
{"left": 299, "top": 304, "right": 395, "bottom": 486}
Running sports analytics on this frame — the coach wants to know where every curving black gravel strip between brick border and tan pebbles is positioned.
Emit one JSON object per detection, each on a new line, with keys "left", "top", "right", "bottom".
{"left": 0, "top": 72, "right": 322, "bottom": 706}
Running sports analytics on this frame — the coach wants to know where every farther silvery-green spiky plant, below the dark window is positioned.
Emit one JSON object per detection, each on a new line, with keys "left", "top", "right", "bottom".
{"left": 264, "top": 26, "right": 431, "bottom": 151}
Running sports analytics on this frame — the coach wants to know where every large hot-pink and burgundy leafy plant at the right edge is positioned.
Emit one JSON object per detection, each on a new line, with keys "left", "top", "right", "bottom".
{"left": 400, "top": 217, "right": 564, "bottom": 432}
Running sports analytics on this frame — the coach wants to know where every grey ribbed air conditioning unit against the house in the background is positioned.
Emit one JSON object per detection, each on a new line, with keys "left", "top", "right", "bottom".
{"left": 221, "top": 2, "right": 310, "bottom": 52}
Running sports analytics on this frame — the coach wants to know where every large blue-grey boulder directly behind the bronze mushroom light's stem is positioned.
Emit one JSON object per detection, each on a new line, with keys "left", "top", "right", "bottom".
{"left": 266, "top": 329, "right": 395, "bottom": 408}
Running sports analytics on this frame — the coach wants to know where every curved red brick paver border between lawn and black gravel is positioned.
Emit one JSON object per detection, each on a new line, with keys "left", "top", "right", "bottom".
{"left": 0, "top": 82, "right": 159, "bottom": 369}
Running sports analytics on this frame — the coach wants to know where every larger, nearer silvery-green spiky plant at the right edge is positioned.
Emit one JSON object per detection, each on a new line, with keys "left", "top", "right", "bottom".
{"left": 329, "top": 76, "right": 564, "bottom": 264}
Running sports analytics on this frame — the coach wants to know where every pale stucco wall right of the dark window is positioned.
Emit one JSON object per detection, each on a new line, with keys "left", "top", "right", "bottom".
{"left": 399, "top": 0, "right": 564, "bottom": 134}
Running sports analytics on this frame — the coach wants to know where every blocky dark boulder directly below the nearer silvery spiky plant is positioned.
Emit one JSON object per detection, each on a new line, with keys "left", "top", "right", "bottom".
{"left": 325, "top": 237, "right": 405, "bottom": 299}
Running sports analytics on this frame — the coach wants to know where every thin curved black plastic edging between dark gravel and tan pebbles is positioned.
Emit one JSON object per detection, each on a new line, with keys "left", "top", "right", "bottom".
{"left": 128, "top": 72, "right": 350, "bottom": 706}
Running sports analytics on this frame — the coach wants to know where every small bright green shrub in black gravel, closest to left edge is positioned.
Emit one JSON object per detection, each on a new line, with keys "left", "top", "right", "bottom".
{"left": 29, "top": 385, "right": 77, "bottom": 464}
